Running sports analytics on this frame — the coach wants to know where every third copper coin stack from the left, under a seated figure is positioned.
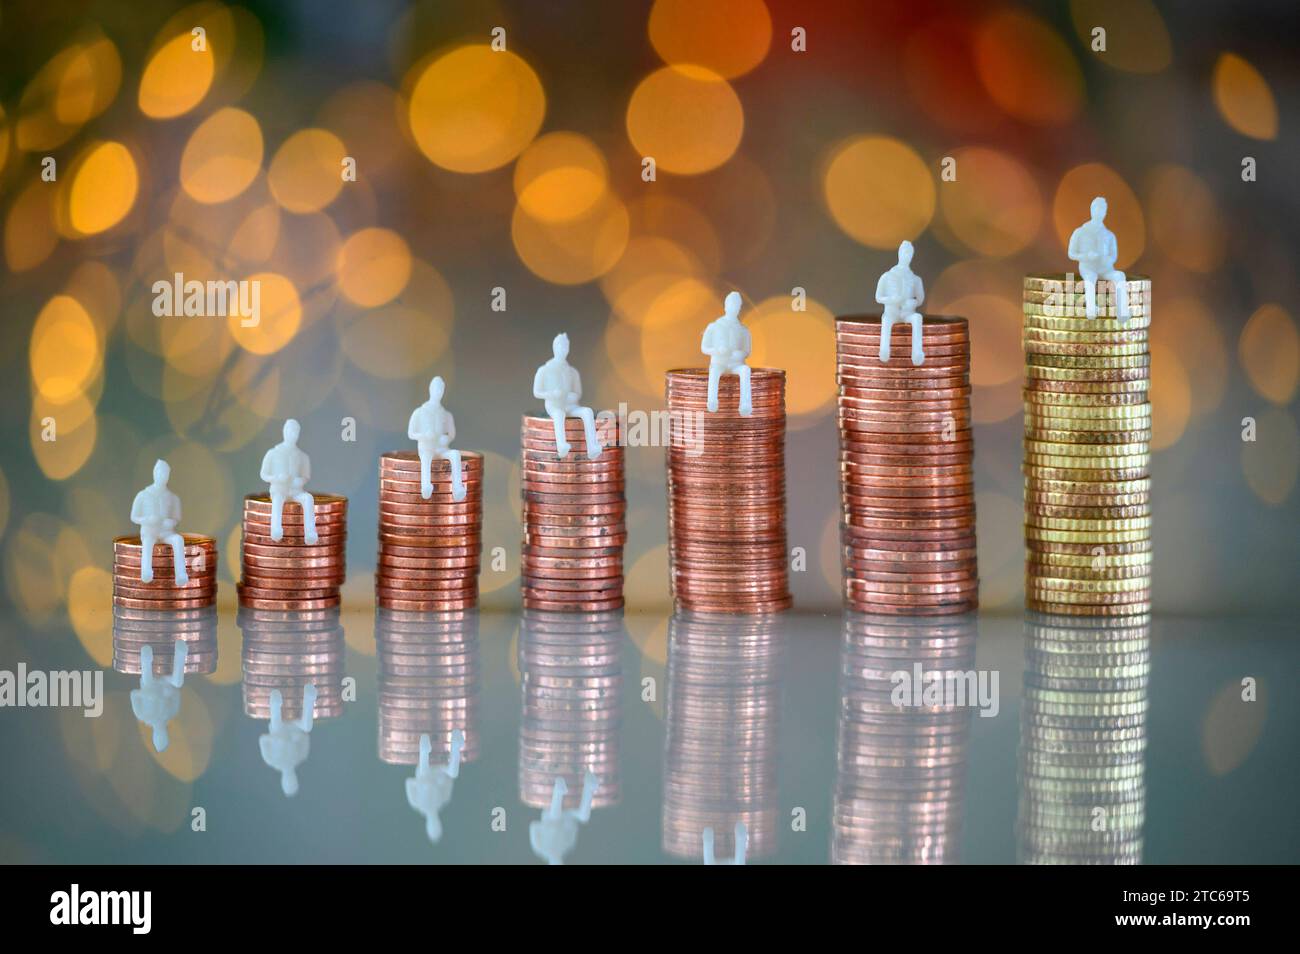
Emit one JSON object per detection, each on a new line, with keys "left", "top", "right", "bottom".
{"left": 374, "top": 451, "right": 484, "bottom": 612}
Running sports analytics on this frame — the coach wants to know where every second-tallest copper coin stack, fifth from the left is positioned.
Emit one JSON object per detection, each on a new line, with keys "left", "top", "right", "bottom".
{"left": 666, "top": 368, "right": 792, "bottom": 613}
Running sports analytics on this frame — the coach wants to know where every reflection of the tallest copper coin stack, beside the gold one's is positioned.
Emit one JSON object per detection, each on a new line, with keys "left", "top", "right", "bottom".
{"left": 831, "top": 613, "right": 976, "bottom": 864}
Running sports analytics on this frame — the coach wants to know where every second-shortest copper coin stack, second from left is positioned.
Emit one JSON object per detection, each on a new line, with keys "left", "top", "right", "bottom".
{"left": 238, "top": 494, "right": 347, "bottom": 613}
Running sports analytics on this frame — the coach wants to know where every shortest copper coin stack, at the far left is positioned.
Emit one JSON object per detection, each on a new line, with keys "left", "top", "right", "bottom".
{"left": 113, "top": 533, "right": 217, "bottom": 610}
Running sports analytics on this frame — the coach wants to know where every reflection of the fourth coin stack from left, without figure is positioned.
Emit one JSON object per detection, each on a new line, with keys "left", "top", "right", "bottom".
{"left": 519, "top": 610, "right": 624, "bottom": 808}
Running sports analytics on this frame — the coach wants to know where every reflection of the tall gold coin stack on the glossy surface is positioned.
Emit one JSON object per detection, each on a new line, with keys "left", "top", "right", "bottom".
{"left": 1019, "top": 615, "right": 1151, "bottom": 864}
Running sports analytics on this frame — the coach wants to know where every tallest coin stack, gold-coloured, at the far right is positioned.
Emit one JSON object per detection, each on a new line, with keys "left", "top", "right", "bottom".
{"left": 1023, "top": 274, "right": 1152, "bottom": 616}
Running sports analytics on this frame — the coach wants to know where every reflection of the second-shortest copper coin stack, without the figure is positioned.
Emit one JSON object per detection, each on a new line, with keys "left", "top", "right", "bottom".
{"left": 238, "top": 607, "right": 345, "bottom": 719}
